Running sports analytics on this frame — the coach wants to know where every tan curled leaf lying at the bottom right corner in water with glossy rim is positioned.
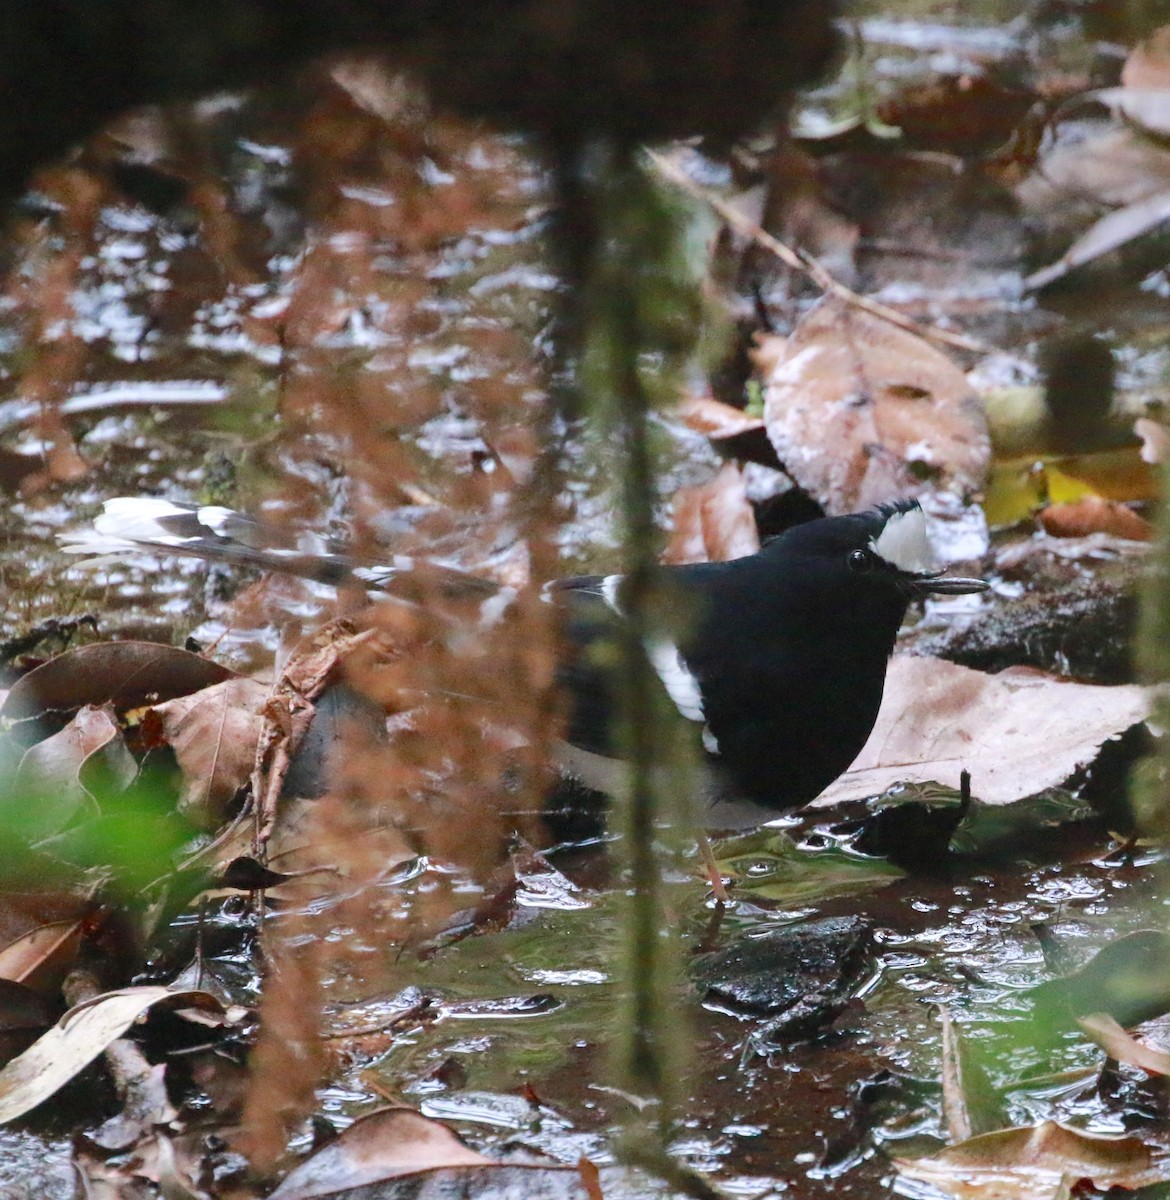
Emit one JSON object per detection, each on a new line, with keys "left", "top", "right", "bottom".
{"left": 895, "top": 1121, "right": 1168, "bottom": 1200}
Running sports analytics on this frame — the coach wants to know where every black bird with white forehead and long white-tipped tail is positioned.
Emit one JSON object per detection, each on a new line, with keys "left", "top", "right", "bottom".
{"left": 62, "top": 498, "right": 988, "bottom": 826}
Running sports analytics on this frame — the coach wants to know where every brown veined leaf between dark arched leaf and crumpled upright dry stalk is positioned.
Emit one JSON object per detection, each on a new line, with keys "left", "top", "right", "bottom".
{"left": 151, "top": 678, "right": 269, "bottom": 820}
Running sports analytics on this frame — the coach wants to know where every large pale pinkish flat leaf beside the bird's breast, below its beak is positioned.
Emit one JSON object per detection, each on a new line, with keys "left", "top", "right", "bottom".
{"left": 817, "top": 655, "right": 1150, "bottom": 805}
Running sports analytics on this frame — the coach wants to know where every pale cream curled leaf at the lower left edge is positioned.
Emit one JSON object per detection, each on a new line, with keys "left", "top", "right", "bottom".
{"left": 0, "top": 988, "right": 235, "bottom": 1124}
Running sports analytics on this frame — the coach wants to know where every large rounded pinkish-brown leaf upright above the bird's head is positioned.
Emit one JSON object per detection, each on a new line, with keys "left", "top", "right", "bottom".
{"left": 756, "top": 301, "right": 991, "bottom": 514}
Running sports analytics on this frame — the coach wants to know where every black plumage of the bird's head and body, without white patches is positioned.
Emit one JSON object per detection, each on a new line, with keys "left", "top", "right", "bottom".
{"left": 562, "top": 512, "right": 910, "bottom": 809}
